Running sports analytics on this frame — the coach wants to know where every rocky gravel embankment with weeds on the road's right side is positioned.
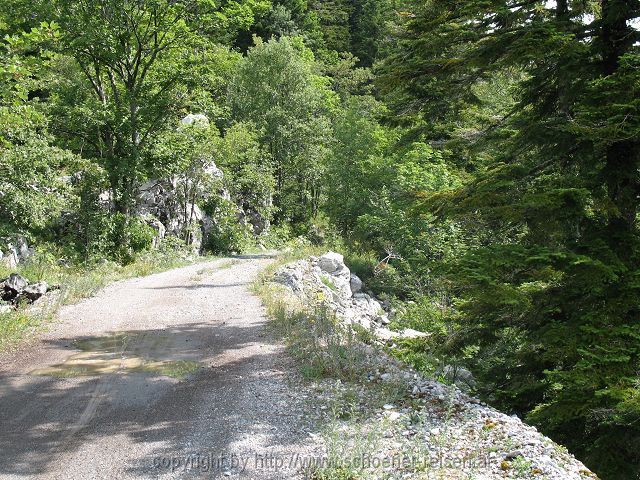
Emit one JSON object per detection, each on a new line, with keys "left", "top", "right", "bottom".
{"left": 272, "top": 252, "right": 595, "bottom": 480}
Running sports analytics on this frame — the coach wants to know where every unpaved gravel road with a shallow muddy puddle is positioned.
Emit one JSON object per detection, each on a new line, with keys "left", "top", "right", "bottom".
{"left": 0, "top": 255, "right": 319, "bottom": 479}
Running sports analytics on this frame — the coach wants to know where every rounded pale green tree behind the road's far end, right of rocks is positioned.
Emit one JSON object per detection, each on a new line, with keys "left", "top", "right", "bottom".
{"left": 229, "top": 38, "right": 335, "bottom": 223}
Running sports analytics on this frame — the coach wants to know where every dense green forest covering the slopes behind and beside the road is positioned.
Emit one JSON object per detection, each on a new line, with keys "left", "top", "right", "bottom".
{"left": 0, "top": 0, "right": 640, "bottom": 479}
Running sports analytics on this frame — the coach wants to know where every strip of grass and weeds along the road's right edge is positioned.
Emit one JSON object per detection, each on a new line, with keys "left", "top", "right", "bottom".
{"left": 254, "top": 249, "right": 424, "bottom": 480}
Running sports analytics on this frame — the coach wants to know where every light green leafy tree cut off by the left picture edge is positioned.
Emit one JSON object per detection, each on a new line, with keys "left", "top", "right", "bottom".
{"left": 0, "top": 23, "right": 82, "bottom": 240}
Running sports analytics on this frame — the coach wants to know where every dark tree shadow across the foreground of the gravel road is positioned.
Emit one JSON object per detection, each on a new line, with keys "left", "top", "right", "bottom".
{"left": 0, "top": 320, "right": 316, "bottom": 478}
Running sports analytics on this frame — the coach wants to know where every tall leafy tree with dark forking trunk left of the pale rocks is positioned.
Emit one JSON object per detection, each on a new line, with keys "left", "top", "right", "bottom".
{"left": 48, "top": 0, "right": 191, "bottom": 219}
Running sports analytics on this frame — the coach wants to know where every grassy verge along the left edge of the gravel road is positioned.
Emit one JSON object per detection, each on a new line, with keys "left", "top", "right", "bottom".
{"left": 0, "top": 252, "right": 210, "bottom": 352}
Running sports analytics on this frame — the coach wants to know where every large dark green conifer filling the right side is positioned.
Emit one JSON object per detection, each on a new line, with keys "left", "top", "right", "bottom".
{"left": 380, "top": 0, "right": 640, "bottom": 478}
